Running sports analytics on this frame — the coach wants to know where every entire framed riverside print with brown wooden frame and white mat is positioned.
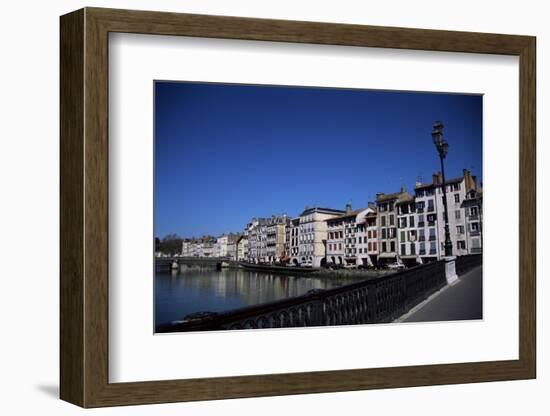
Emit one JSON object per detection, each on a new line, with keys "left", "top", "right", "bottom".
{"left": 60, "top": 8, "right": 536, "bottom": 407}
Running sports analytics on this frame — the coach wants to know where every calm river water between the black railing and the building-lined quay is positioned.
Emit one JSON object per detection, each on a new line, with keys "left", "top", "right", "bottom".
{"left": 155, "top": 266, "right": 357, "bottom": 325}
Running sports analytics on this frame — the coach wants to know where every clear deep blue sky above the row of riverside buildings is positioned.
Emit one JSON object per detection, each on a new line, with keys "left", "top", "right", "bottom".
{"left": 155, "top": 81, "right": 482, "bottom": 237}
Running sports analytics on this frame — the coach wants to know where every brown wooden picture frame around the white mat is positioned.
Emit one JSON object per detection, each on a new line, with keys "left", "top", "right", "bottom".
{"left": 60, "top": 8, "right": 536, "bottom": 407}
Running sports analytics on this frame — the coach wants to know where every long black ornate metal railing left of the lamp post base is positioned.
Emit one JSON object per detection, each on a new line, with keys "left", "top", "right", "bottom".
{"left": 156, "top": 261, "right": 446, "bottom": 332}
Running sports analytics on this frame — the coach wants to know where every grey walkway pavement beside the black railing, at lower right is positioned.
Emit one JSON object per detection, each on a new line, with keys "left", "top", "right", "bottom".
{"left": 400, "top": 266, "right": 483, "bottom": 322}
